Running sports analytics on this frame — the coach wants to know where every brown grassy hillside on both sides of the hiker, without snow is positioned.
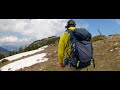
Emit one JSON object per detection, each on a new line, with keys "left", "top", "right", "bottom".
{"left": 18, "top": 34, "right": 120, "bottom": 71}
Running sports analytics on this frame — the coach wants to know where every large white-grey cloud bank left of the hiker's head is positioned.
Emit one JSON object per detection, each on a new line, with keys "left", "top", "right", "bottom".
{"left": 0, "top": 19, "right": 68, "bottom": 45}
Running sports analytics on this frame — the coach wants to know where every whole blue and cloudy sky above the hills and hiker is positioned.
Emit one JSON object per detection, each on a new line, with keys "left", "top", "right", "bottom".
{"left": 0, "top": 19, "right": 120, "bottom": 46}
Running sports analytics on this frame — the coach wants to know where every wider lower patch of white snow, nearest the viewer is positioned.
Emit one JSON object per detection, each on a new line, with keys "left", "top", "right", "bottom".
{"left": 0, "top": 53, "right": 48, "bottom": 71}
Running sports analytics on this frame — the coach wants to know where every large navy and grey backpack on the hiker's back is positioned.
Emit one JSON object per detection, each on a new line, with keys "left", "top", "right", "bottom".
{"left": 66, "top": 28, "right": 95, "bottom": 69}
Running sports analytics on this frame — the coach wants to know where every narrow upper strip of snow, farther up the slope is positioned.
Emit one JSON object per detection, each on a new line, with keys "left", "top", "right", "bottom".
{"left": 0, "top": 46, "right": 48, "bottom": 61}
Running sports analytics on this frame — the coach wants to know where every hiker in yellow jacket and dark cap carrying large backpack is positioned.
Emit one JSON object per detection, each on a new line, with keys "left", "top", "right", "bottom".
{"left": 58, "top": 20, "right": 93, "bottom": 70}
